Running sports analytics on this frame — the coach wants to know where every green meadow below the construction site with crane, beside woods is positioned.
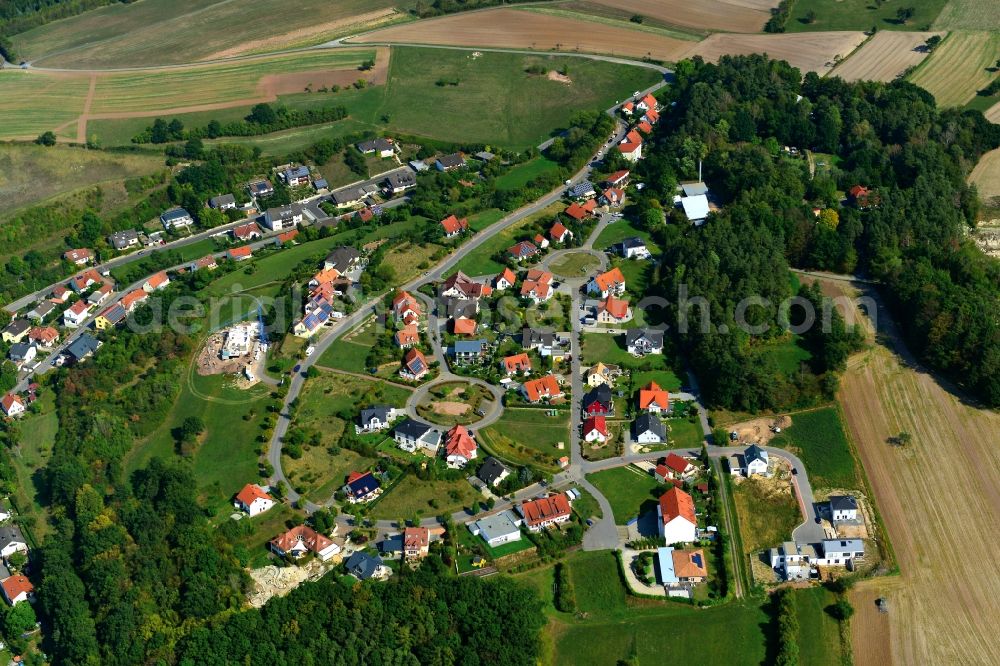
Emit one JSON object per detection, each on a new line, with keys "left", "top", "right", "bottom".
{"left": 125, "top": 370, "right": 269, "bottom": 514}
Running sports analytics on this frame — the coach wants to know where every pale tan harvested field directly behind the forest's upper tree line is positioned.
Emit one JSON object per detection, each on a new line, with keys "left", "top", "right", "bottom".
{"left": 686, "top": 32, "right": 865, "bottom": 74}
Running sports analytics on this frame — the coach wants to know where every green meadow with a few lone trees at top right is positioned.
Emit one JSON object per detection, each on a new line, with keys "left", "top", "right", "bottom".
{"left": 785, "top": 0, "right": 948, "bottom": 32}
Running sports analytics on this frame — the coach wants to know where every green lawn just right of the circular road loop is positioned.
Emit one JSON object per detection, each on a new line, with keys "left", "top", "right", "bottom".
{"left": 479, "top": 407, "right": 569, "bottom": 470}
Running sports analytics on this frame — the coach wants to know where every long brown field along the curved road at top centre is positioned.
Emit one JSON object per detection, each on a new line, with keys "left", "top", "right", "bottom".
{"left": 350, "top": 8, "right": 691, "bottom": 62}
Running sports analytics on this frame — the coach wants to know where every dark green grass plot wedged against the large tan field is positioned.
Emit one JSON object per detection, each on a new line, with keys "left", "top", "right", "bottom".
{"left": 771, "top": 407, "right": 864, "bottom": 490}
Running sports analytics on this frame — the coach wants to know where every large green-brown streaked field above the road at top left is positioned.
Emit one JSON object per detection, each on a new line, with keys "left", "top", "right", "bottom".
{"left": 13, "top": 0, "right": 402, "bottom": 69}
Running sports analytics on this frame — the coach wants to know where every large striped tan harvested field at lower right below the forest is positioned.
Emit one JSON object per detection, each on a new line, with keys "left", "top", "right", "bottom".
{"left": 820, "top": 274, "right": 1000, "bottom": 666}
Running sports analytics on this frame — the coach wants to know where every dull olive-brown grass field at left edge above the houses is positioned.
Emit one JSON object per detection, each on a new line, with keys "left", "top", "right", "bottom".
{"left": 0, "top": 144, "right": 166, "bottom": 219}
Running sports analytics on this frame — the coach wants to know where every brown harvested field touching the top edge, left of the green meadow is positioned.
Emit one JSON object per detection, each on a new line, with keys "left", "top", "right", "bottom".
{"left": 576, "top": 0, "right": 777, "bottom": 32}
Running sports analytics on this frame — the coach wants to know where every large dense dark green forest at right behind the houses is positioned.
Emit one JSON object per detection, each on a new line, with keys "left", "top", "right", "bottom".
{"left": 638, "top": 56, "right": 1000, "bottom": 410}
